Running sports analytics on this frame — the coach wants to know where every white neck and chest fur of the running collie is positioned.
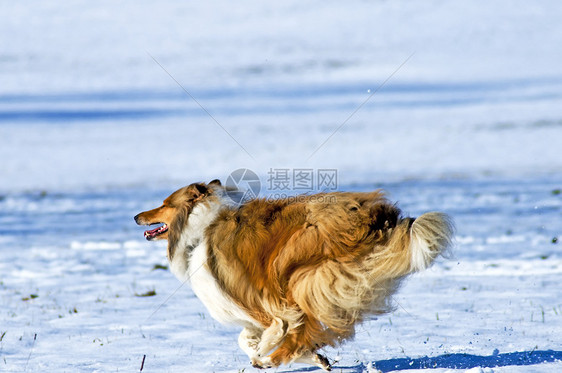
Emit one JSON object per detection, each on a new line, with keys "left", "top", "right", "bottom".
{"left": 170, "top": 198, "right": 258, "bottom": 325}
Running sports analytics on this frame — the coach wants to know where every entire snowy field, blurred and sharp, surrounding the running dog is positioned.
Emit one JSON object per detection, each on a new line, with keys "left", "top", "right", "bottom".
{"left": 0, "top": 0, "right": 562, "bottom": 372}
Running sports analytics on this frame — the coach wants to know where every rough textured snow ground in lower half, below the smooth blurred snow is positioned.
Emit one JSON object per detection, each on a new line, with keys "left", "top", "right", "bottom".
{"left": 0, "top": 178, "right": 562, "bottom": 372}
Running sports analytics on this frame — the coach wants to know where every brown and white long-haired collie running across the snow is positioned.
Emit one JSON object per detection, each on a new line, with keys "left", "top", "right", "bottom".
{"left": 135, "top": 180, "right": 453, "bottom": 370}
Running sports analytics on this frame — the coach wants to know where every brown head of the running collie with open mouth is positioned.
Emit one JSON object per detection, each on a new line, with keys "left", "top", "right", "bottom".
{"left": 135, "top": 180, "right": 221, "bottom": 241}
